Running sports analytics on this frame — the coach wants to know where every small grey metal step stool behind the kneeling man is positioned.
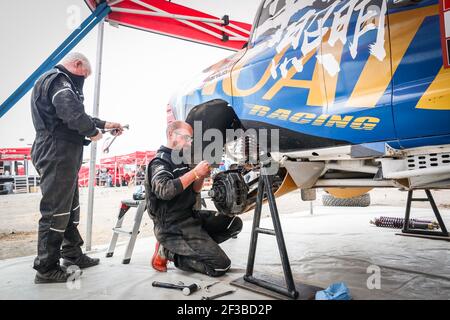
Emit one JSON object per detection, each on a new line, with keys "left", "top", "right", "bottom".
{"left": 106, "top": 200, "right": 147, "bottom": 264}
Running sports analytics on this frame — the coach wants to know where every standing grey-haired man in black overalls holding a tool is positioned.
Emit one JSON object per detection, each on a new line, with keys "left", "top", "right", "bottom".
{"left": 31, "top": 53, "right": 123, "bottom": 283}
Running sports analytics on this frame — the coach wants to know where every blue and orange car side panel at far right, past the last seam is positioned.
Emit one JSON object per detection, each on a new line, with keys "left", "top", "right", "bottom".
{"left": 388, "top": 0, "right": 450, "bottom": 147}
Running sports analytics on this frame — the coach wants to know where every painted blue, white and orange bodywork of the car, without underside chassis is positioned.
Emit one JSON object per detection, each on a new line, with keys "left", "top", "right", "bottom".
{"left": 169, "top": 0, "right": 450, "bottom": 192}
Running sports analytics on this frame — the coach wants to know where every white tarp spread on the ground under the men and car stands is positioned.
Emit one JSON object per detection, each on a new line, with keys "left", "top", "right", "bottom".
{"left": 0, "top": 206, "right": 450, "bottom": 300}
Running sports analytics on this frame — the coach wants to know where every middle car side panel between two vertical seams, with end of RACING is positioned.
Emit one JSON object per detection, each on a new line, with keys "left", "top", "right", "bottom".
{"left": 320, "top": 0, "right": 395, "bottom": 143}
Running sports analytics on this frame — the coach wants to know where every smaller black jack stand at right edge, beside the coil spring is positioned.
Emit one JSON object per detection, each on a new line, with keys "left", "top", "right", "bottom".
{"left": 397, "top": 189, "right": 450, "bottom": 241}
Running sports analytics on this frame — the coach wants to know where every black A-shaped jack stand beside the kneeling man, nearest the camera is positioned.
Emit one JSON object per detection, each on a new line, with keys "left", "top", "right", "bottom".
{"left": 230, "top": 158, "right": 322, "bottom": 299}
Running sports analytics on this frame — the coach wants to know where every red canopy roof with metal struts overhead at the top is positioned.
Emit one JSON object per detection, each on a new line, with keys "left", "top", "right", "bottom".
{"left": 85, "top": 0, "right": 251, "bottom": 51}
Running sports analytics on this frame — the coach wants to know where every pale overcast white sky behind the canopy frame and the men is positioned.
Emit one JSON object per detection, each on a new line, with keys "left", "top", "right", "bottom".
{"left": 0, "top": 0, "right": 260, "bottom": 159}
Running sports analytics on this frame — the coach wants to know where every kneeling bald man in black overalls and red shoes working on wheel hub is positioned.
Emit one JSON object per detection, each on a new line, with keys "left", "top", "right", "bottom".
{"left": 145, "top": 121, "right": 242, "bottom": 277}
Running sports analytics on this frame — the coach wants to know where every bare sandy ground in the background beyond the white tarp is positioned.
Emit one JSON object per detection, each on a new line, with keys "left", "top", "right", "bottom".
{"left": 0, "top": 187, "right": 450, "bottom": 260}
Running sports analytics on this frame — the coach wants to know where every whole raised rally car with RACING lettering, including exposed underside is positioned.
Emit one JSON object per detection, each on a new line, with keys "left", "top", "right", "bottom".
{"left": 168, "top": 0, "right": 450, "bottom": 215}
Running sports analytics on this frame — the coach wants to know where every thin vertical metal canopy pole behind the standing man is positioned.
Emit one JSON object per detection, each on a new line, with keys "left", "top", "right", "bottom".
{"left": 86, "top": 21, "right": 104, "bottom": 251}
